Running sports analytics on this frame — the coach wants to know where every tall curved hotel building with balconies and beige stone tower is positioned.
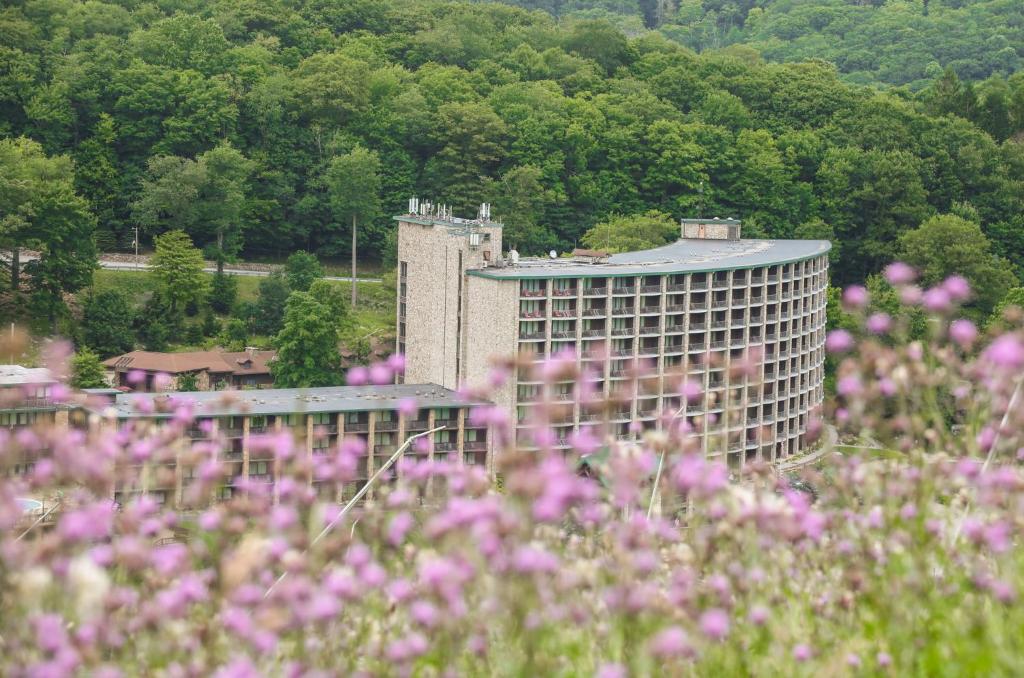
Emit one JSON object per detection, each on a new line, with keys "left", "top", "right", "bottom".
{"left": 395, "top": 210, "right": 830, "bottom": 467}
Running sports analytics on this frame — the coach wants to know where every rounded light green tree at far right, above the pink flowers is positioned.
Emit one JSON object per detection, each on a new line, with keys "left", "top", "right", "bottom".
{"left": 899, "top": 214, "right": 1019, "bottom": 315}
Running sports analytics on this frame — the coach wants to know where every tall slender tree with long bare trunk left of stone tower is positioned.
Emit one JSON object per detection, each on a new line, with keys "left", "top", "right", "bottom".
{"left": 325, "top": 145, "right": 381, "bottom": 308}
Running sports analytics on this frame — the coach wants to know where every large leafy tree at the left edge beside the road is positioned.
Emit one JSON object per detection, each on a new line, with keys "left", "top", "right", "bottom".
{"left": 0, "top": 138, "right": 96, "bottom": 311}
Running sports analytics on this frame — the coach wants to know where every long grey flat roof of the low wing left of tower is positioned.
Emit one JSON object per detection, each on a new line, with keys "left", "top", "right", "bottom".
{"left": 97, "top": 384, "right": 483, "bottom": 419}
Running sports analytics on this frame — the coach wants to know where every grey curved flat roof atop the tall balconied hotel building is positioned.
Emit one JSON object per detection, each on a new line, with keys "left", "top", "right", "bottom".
{"left": 466, "top": 238, "right": 831, "bottom": 280}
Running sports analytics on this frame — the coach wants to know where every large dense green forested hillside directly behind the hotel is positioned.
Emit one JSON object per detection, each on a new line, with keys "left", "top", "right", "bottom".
{"left": 0, "top": 0, "right": 1024, "bottom": 315}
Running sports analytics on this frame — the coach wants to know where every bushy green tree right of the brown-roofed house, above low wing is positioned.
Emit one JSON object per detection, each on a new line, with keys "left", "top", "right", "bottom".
{"left": 270, "top": 292, "right": 341, "bottom": 388}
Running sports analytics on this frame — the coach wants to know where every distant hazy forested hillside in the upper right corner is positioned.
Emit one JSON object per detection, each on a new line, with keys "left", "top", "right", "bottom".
{"left": 495, "top": 0, "right": 1024, "bottom": 90}
